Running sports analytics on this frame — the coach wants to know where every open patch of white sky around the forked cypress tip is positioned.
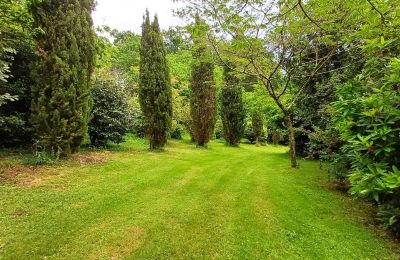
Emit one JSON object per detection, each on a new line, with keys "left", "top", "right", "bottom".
{"left": 93, "top": 0, "right": 182, "bottom": 33}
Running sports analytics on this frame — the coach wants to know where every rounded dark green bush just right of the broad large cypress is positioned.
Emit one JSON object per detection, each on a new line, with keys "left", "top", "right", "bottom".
{"left": 89, "top": 78, "right": 131, "bottom": 147}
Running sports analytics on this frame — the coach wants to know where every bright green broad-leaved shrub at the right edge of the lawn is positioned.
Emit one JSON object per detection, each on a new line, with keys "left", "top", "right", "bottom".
{"left": 333, "top": 29, "right": 400, "bottom": 235}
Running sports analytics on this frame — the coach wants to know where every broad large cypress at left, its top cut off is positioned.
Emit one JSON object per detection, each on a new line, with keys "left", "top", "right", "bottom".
{"left": 31, "top": 0, "right": 95, "bottom": 156}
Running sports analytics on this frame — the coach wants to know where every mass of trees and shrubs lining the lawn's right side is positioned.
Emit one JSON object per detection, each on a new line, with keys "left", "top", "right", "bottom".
{"left": 179, "top": 0, "right": 400, "bottom": 236}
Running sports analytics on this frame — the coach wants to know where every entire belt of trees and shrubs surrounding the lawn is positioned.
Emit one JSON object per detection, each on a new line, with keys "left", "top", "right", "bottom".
{"left": 0, "top": 0, "right": 400, "bottom": 237}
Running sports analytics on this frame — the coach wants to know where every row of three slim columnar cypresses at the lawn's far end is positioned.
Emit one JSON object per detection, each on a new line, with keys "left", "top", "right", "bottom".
{"left": 139, "top": 12, "right": 250, "bottom": 149}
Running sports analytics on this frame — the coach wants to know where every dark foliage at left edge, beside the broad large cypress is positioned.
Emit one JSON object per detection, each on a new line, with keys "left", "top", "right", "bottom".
{"left": 0, "top": 0, "right": 35, "bottom": 147}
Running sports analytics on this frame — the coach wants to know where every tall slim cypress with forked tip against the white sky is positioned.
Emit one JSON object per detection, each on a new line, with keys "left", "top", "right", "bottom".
{"left": 139, "top": 11, "right": 172, "bottom": 149}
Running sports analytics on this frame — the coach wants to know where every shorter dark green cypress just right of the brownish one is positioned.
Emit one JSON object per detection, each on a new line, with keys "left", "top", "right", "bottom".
{"left": 220, "top": 66, "right": 246, "bottom": 146}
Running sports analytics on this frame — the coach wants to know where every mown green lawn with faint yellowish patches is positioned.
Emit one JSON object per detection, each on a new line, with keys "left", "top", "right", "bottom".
{"left": 0, "top": 139, "right": 400, "bottom": 259}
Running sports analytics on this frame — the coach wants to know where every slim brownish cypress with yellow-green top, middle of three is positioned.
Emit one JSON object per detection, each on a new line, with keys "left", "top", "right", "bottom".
{"left": 190, "top": 16, "right": 216, "bottom": 146}
